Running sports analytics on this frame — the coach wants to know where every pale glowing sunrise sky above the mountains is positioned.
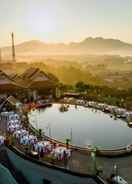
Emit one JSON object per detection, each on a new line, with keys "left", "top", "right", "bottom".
{"left": 0, "top": 0, "right": 132, "bottom": 46}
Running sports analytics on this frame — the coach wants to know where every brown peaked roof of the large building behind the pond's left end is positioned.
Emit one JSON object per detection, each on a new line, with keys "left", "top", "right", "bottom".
{"left": 0, "top": 68, "right": 58, "bottom": 89}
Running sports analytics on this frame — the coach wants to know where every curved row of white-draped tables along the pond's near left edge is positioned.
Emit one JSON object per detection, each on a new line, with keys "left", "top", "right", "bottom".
{"left": 7, "top": 110, "right": 71, "bottom": 160}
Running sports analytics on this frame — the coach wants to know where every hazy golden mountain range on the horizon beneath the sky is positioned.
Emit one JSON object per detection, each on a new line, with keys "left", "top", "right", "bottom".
{"left": 2, "top": 37, "right": 132, "bottom": 56}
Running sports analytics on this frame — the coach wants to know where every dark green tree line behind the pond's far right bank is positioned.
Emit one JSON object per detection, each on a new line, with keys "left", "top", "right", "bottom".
{"left": 59, "top": 81, "right": 132, "bottom": 110}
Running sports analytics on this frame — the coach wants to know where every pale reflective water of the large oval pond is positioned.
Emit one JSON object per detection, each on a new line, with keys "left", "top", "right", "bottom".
{"left": 29, "top": 104, "right": 132, "bottom": 149}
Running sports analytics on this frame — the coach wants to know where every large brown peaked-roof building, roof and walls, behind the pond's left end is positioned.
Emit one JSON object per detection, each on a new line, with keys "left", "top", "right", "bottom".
{"left": 0, "top": 68, "right": 58, "bottom": 98}
